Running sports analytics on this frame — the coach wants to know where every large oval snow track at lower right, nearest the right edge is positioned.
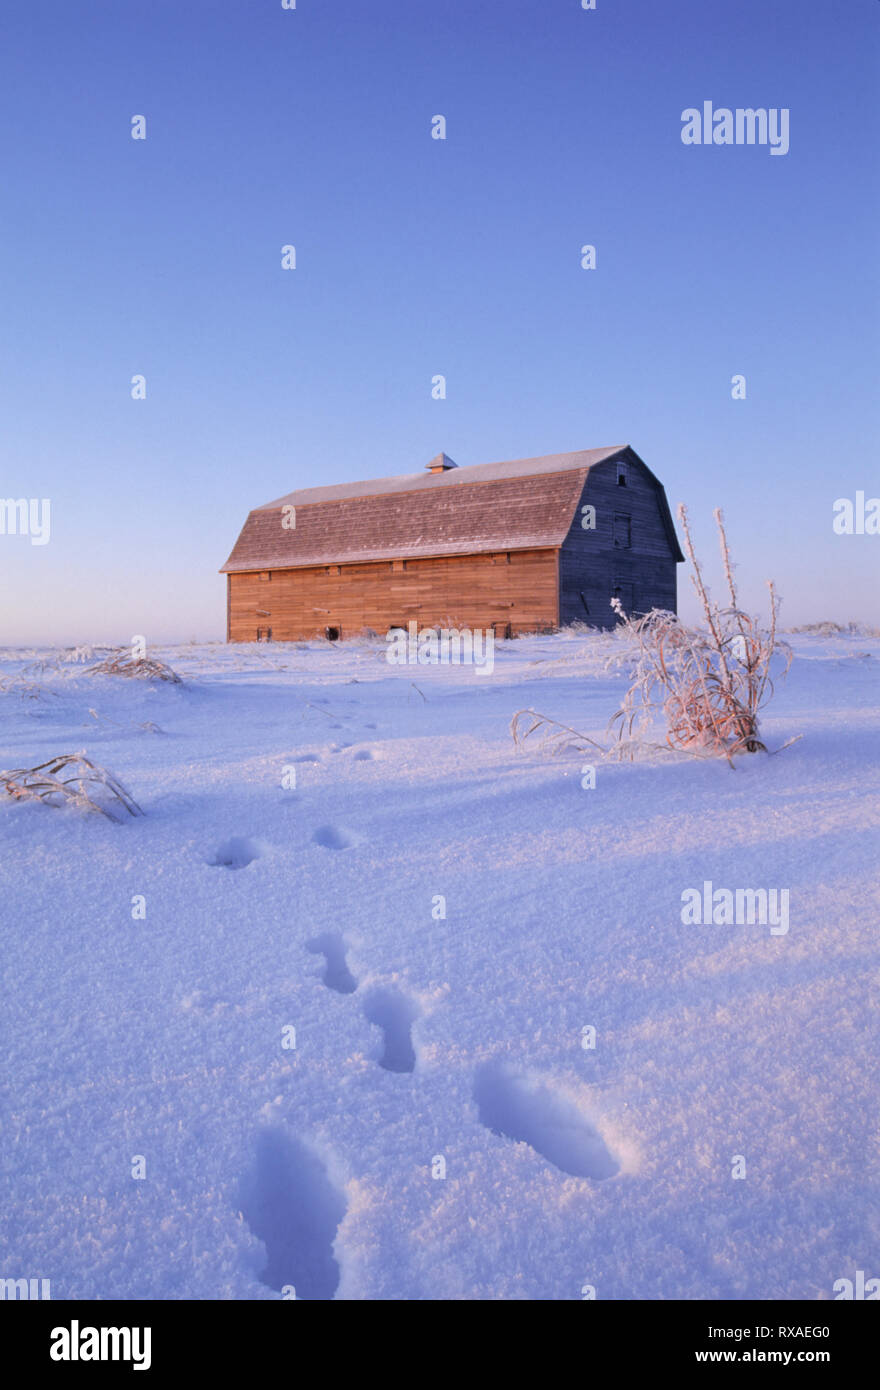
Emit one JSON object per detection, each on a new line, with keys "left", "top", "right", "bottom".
{"left": 474, "top": 1062, "right": 620, "bottom": 1182}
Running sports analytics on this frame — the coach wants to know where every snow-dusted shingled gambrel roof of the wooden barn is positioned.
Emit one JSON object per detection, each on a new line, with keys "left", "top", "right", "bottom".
{"left": 221, "top": 445, "right": 681, "bottom": 574}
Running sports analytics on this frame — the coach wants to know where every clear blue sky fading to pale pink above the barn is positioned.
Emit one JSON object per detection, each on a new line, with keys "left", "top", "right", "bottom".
{"left": 0, "top": 0, "right": 880, "bottom": 644}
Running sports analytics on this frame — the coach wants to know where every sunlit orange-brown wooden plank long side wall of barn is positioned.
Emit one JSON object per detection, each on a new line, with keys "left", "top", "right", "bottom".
{"left": 228, "top": 548, "right": 559, "bottom": 642}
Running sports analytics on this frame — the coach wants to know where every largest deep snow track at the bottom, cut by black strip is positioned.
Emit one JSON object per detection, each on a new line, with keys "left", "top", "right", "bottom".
{"left": 239, "top": 1127, "right": 346, "bottom": 1300}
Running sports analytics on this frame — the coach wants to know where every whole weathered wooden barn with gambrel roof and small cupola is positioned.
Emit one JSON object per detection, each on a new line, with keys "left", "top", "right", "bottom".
{"left": 221, "top": 445, "right": 683, "bottom": 642}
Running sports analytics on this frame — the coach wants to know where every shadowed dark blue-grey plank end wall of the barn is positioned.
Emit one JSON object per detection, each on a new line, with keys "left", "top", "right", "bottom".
{"left": 559, "top": 456, "right": 680, "bottom": 627}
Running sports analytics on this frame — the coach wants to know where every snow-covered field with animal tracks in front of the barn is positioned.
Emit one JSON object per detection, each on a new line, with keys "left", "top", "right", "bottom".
{"left": 0, "top": 634, "right": 880, "bottom": 1300}
